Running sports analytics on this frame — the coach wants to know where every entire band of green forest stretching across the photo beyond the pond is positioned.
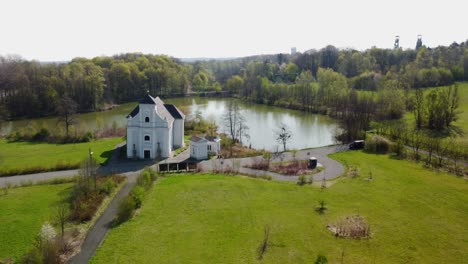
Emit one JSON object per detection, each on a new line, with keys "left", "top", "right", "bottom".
{"left": 0, "top": 38, "right": 468, "bottom": 141}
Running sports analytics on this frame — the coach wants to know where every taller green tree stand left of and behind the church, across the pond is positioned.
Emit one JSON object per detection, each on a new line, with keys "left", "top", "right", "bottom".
{"left": 0, "top": 54, "right": 192, "bottom": 119}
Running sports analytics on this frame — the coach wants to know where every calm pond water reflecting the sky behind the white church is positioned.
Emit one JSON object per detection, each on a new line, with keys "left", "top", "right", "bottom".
{"left": 0, "top": 97, "right": 337, "bottom": 150}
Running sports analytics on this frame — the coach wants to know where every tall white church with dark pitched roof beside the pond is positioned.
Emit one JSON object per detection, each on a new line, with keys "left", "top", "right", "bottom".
{"left": 127, "top": 94, "right": 185, "bottom": 159}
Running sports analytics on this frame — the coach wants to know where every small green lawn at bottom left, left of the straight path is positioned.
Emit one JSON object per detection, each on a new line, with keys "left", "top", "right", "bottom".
{"left": 0, "top": 184, "right": 72, "bottom": 260}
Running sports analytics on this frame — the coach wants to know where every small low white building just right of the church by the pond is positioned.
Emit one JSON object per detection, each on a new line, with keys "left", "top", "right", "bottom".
{"left": 190, "top": 136, "right": 221, "bottom": 160}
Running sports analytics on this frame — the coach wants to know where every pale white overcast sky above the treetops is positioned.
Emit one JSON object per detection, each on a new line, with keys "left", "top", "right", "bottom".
{"left": 0, "top": 0, "right": 468, "bottom": 61}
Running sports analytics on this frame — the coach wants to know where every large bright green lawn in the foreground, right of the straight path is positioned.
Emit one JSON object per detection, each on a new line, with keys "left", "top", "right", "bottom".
{"left": 92, "top": 151, "right": 468, "bottom": 263}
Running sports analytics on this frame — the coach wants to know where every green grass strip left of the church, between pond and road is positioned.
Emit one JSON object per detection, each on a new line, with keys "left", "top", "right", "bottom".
{"left": 0, "top": 138, "right": 123, "bottom": 174}
